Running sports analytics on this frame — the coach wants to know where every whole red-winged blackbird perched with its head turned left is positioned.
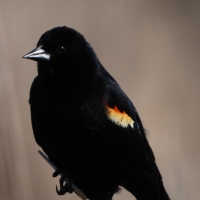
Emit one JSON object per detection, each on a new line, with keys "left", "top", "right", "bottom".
{"left": 24, "top": 27, "right": 169, "bottom": 200}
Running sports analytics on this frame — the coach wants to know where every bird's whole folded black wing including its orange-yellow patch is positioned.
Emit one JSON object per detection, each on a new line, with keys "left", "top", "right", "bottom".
{"left": 99, "top": 77, "right": 169, "bottom": 199}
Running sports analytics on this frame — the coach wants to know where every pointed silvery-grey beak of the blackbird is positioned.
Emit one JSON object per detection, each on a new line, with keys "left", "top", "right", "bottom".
{"left": 22, "top": 46, "right": 51, "bottom": 61}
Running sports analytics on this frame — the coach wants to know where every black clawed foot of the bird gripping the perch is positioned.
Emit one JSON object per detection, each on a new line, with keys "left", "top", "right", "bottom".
{"left": 53, "top": 169, "right": 74, "bottom": 195}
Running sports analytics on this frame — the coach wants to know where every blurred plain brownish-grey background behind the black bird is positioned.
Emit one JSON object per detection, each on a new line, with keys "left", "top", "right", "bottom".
{"left": 0, "top": 0, "right": 200, "bottom": 200}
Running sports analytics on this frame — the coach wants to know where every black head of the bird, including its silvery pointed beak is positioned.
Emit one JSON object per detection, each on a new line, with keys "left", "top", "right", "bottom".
{"left": 23, "top": 26, "right": 98, "bottom": 77}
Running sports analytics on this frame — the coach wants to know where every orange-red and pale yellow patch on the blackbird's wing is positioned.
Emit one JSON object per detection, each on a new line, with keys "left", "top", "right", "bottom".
{"left": 106, "top": 105, "right": 134, "bottom": 128}
